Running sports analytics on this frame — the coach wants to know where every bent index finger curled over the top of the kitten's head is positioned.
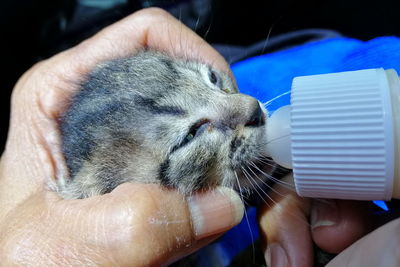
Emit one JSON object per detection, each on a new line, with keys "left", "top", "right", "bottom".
{"left": 16, "top": 8, "right": 230, "bottom": 114}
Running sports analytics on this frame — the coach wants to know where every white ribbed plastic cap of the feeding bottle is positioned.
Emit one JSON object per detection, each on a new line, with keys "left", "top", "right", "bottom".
{"left": 291, "top": 69, "right": 394, "bottom": 200}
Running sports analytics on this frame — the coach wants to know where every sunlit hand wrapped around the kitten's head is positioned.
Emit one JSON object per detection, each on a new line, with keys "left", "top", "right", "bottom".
{"left": 0, "top": 9, "right": 243, "bottom": 266}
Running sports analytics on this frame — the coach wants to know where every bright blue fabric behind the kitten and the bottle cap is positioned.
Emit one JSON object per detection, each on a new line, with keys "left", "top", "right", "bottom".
{"left": 217, "top": 37, "right": 400, "bottom": 265}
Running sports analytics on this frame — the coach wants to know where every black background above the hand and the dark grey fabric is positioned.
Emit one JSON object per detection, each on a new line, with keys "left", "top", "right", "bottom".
{"left": 0, "top": 0, "right": 400, "bottom": 151}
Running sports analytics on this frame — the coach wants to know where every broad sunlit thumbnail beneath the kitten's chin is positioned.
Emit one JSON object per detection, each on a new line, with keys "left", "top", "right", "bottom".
{"left": 188, "top": 187, "right": 244, "bottom": 239}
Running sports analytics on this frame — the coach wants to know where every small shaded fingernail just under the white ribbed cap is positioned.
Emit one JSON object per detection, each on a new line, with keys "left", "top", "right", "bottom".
{"left": 310, "top": 200, "right": 339, "bottom": 229}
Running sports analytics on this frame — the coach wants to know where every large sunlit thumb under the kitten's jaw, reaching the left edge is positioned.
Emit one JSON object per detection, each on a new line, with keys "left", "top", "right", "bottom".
{"left": 0, "top": 184, "right": 244, "bottom": 266}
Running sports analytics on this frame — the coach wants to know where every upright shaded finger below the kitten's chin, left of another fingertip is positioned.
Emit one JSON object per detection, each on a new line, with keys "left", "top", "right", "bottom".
{"left": 259, "top": 176, "right": 313, "bottom": 267}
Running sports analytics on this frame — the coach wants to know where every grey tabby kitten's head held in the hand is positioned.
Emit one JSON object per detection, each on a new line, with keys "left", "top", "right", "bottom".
{"left": 58, "top": 51, "right": 265, "bottom": 198}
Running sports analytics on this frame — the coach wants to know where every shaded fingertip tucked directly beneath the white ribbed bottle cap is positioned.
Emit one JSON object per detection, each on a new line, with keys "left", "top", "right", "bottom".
{"left": 311, "top": 200, "right": 373, "bottom": 253}
